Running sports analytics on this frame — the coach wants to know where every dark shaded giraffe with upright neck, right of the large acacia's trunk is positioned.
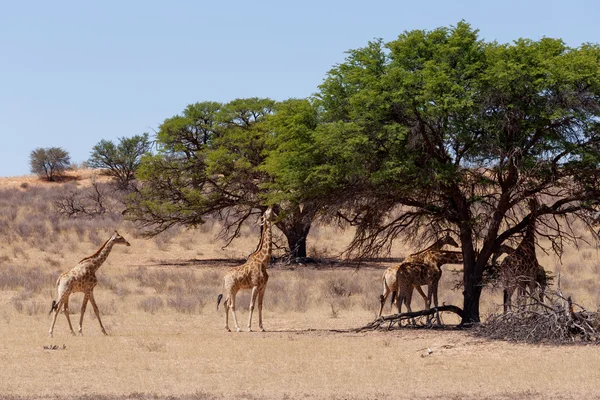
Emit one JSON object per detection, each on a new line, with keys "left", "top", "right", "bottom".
{"left": 500, "top": 199, "right": 546, "bottom": 314}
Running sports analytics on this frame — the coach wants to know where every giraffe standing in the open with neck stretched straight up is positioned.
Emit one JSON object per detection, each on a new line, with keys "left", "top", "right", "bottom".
{"left": 217, "top": 207, "right": 274, "bottom": 332}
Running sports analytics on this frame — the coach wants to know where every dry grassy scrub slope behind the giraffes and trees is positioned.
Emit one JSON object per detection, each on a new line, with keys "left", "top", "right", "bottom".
{"left": 0, "top": 169, "right": 600, "bottom": 326}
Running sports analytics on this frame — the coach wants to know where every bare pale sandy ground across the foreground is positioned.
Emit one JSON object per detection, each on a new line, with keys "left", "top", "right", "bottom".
{"left": 0, "top": 300, "right": 600, "bottom": 399}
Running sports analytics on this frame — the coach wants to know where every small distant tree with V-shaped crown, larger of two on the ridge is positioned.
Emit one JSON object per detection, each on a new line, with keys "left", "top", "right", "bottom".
{"left": 86, "top": 133, "right": 151, "bottom": 187}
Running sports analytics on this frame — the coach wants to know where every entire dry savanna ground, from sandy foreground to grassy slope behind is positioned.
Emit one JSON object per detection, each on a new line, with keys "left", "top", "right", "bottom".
{"left": 0, "top": 171, "right": 600, "bottom": 399}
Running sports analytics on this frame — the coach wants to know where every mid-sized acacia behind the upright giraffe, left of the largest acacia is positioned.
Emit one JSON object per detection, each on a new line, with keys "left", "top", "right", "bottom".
{"left": 128, "top": 98, "right": 316, "bottom": 257}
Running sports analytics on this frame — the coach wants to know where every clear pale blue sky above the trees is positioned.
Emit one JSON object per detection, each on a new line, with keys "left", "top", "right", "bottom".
{"left": 0, "top": 0, "right": 600, "bottom": 176}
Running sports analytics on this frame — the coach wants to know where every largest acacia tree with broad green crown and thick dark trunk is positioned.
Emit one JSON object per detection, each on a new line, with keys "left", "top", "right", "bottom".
{"left": 280, "top": 22, "right": 600, "bottom": 323}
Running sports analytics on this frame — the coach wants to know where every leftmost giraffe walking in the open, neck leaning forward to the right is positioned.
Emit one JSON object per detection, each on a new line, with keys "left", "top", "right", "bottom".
{"left": 49, "top": 231, "right": 130, "bottom": 337}
